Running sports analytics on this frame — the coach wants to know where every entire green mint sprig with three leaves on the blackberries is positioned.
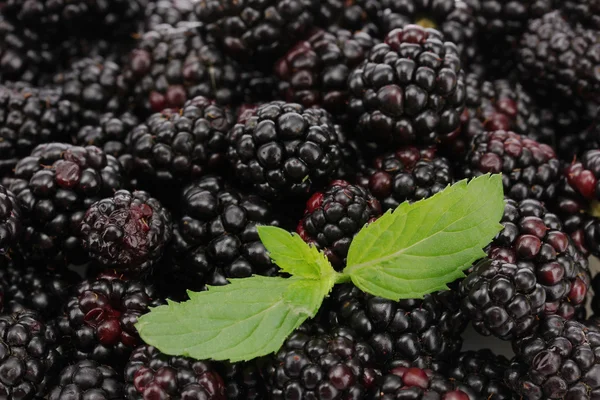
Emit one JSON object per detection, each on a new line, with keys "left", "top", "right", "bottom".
{"left": 136, "top": 175, "right": 504, "bottom": 362}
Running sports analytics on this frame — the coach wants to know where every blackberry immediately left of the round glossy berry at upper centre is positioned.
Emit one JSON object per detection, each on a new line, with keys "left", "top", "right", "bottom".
{"left": 126, "top": 97, "right": 235, "bottom": 190}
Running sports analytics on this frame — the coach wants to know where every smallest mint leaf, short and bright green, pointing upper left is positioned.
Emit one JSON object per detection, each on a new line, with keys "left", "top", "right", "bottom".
{"left": 257, "top": 226, "right": 335, "bottom": 279}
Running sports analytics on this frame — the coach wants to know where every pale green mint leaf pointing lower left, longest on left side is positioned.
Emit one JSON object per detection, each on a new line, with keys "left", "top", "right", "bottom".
{"left": 136, "top": 276, "right": 335, "bottom": 362}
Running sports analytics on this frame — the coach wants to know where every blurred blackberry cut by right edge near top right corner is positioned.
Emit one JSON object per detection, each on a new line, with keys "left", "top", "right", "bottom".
{"left": 518, "top": 12, "right": 600, "bottom": 104}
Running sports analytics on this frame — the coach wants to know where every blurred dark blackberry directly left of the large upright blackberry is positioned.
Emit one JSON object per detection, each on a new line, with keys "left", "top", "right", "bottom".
{"left": 275, "top": 29, "right": 377, "bottom": 122}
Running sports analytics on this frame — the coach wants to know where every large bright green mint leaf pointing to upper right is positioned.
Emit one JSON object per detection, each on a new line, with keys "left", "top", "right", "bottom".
{"left": 343, "top": 174, "right": 504, "bottom": 300}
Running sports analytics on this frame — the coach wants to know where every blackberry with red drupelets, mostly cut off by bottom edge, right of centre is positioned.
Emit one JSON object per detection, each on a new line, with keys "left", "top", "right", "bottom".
{"left": 369, "top": 367, "right": 476, "bottom": 400}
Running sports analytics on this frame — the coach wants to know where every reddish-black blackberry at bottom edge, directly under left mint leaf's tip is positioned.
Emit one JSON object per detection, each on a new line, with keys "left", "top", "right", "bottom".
{"left": 125, "top": 345, "right": 226, "bottom": 400}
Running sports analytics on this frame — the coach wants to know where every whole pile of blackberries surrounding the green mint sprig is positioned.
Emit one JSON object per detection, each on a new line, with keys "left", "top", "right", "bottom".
{"left": 0, "top": 0, "right": 600, "bottom": 400}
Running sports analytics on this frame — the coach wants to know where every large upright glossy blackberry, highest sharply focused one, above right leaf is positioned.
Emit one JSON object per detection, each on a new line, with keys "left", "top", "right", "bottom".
{"left": 348, "top": 25, "right": 465, "bottom": 149}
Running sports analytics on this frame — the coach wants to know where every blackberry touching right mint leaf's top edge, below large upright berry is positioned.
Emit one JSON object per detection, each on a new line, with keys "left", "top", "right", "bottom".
{"left": 358, "top": 146, "right": 454, "bottom": 212}
